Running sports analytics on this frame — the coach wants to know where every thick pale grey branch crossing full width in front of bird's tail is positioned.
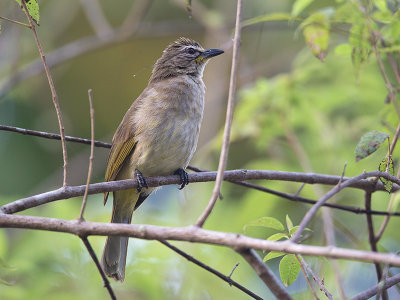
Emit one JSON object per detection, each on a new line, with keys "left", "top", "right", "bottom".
{"left": 0, "top": 214, "right": 400, "bottom": 266}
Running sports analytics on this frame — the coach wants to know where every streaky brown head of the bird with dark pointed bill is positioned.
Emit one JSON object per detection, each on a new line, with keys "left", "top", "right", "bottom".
{"left": 150, "top": 37, "right": 224, "bottom": 81}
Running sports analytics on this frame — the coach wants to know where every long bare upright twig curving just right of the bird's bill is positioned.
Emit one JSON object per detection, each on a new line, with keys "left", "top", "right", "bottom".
{"left": 196, "top": 0, "right": 242, "bottom": 227}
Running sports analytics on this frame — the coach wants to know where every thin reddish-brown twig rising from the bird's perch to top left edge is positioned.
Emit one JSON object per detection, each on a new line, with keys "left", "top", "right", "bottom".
{"left": 21, "top": 1, "right": 68, "bottom": 187}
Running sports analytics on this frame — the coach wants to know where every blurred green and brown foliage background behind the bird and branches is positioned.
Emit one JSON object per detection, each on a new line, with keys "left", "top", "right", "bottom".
{"left": 0, "top": 0, "right": 400, "bottom": 300}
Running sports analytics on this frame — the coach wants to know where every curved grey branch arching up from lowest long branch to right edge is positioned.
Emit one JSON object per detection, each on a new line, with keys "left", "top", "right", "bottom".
{"left": 291, "top": 171, "right": 400, "bottom": 241}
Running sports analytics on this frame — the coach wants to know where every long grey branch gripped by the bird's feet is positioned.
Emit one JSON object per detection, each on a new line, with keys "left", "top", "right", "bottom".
{"left": 0, "top": 170, "right": 400, "bottom": 214}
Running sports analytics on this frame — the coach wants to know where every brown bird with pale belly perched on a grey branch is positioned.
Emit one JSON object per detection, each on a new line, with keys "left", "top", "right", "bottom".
{"left": 101, "top": 37, "right": 224, "bottom": 282}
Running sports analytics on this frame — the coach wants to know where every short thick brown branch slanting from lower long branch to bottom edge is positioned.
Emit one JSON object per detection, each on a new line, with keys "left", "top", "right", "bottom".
{"left": 237, "top": 249, "right": 292, "bottom": 300}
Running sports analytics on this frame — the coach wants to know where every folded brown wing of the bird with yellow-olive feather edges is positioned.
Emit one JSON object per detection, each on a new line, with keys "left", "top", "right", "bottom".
{"left": 104, "top": 128, "right": 136, "bottom": 204}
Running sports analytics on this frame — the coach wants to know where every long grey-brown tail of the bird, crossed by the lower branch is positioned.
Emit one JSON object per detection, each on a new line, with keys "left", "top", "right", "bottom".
{"left": 101, "top": 190, "right": 140, "bottom": 282}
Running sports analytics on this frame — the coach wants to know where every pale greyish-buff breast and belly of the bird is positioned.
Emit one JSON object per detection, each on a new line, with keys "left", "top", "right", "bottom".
{"left": 131, "top": 76, "right": 204, "bottom": 176}
